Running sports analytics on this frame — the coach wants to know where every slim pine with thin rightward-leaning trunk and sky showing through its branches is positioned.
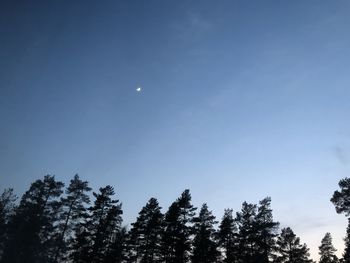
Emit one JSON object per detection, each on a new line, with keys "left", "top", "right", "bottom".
{"left": 54, "top": 175, "right": 91, "bottom": 262}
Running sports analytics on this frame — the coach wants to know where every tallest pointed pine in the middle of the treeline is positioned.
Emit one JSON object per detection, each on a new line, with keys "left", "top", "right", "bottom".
{"left": 162, "top": 190, "right": 196, "bottom": 263}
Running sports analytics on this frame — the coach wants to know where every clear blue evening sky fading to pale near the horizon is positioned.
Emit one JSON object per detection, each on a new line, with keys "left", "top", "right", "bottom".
{"left": 0, "top": 0, "right": 350, "bottom": 258}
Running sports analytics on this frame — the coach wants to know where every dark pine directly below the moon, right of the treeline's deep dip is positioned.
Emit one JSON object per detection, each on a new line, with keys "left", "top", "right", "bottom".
{"left": 129, "top": 198, "right": 163, "bottom": 263}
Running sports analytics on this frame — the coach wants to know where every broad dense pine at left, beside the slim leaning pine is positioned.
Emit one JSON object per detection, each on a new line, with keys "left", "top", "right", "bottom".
{"left": 3, "top": 175, "right": 64, "bottom": 263}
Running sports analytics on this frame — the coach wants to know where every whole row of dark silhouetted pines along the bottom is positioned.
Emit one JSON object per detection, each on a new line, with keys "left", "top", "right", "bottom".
{"left": 0, "top": 175, "right": 350, "bottom": 263}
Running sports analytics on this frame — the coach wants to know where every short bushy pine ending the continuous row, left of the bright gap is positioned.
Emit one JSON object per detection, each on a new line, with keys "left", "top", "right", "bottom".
{"left": 276, "top": 227, "right": 313, "bottom": 263}
